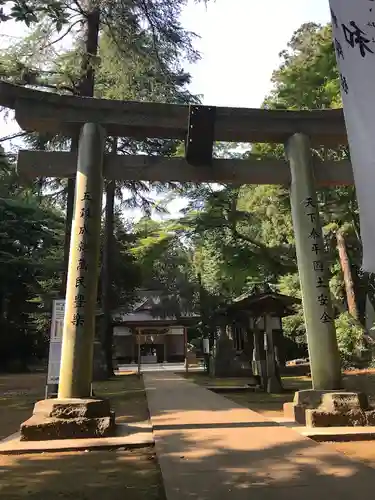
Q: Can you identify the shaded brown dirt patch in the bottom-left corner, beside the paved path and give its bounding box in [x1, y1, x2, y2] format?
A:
[0, 449, 165, 500]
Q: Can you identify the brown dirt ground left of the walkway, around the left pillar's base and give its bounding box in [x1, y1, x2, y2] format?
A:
[0, 374, 165, 500]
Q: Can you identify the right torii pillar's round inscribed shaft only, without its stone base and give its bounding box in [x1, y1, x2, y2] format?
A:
[286, 134, 342, 390]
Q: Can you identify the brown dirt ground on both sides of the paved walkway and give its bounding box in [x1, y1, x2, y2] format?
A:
[0, 372, 375, 494]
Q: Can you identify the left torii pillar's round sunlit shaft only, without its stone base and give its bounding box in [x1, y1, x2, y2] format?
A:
[59, 123, 105, 399]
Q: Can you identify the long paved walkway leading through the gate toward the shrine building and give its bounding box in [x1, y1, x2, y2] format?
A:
[144, 373, 375, 500]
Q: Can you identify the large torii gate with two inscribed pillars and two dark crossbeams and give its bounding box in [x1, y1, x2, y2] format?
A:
[0, 82, 362, 440]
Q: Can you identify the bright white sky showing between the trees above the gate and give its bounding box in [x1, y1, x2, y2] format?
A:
[0, 0, 330, 219]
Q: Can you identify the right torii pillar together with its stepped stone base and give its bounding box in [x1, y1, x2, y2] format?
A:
[284, 133, 373, 427]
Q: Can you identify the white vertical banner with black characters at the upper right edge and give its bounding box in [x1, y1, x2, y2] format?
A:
[330, 0, 375, 272]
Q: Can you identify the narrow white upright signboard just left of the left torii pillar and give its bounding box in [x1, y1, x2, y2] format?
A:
[46, 299, 65, 396]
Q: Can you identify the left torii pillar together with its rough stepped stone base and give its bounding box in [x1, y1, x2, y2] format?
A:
[21, 123, 115, 441]
